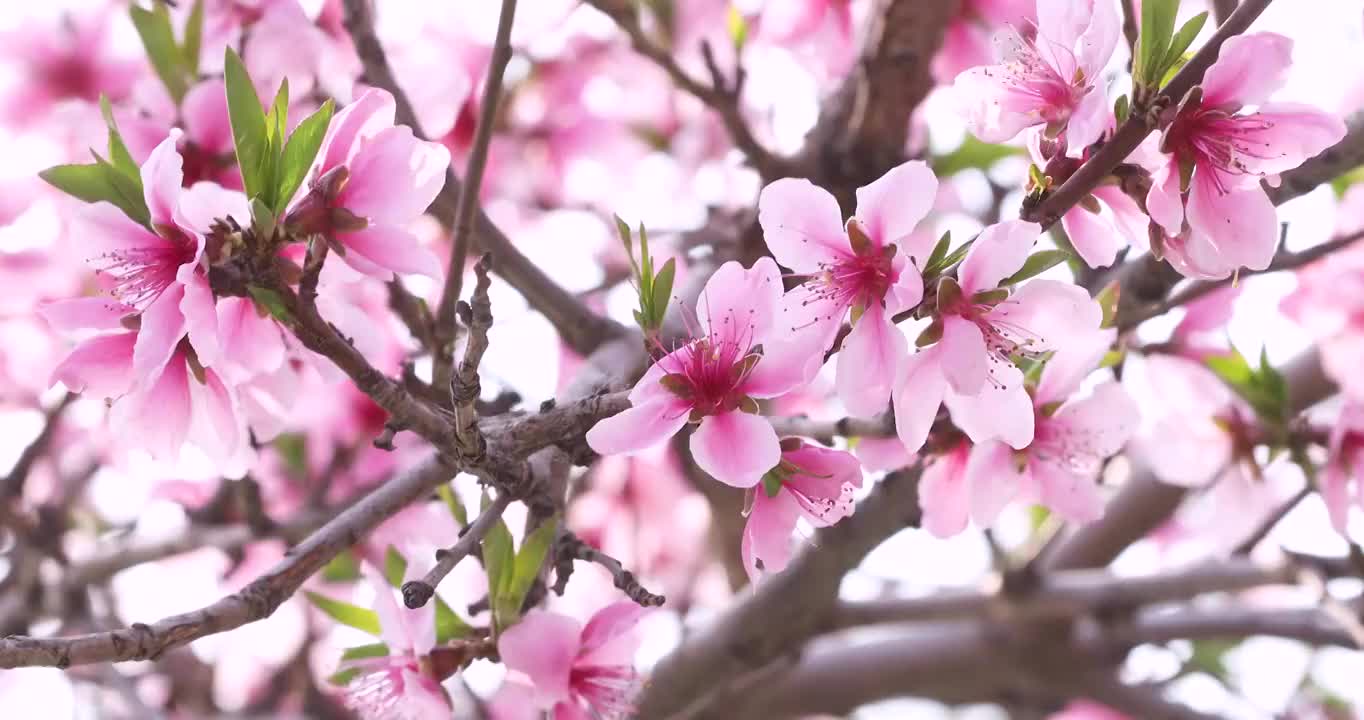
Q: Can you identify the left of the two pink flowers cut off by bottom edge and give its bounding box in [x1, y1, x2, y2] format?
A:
[342, 565, 451, 720]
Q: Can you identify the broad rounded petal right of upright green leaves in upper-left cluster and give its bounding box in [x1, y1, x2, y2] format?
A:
[337, 127, 450, 225]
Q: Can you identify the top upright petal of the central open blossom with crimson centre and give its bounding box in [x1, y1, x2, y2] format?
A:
[696, 258, 783, 345]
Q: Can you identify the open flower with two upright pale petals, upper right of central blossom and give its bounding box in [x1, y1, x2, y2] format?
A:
[758, 161, 938, 416]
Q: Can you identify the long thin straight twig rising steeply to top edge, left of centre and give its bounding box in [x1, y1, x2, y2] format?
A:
[431, 0, 516, 387]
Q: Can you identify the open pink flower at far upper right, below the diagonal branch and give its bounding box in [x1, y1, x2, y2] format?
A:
[1146, 33, 1345, 278]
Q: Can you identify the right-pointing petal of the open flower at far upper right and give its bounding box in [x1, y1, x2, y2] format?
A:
[1240, 102, 1345, 175]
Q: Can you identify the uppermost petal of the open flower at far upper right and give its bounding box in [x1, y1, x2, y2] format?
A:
[1203, 33, 1293, 109]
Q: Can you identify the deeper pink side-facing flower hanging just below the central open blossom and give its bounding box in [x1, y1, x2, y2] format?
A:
[742, 438, 862, 581]
